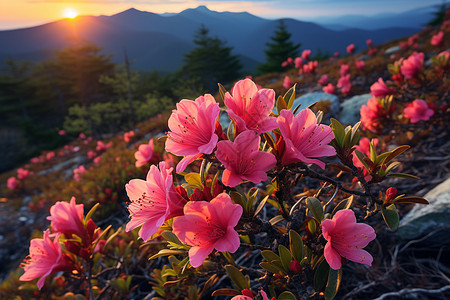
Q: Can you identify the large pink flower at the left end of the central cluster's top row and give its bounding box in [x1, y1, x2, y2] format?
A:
[166, 94, 220, 172]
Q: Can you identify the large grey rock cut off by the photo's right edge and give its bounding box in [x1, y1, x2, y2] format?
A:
[397, 177, 450, 240]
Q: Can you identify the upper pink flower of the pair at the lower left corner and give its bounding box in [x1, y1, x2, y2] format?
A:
[47, 197, 85, 238]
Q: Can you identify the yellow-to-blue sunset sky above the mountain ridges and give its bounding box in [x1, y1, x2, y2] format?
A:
[0, 0, 443, 30]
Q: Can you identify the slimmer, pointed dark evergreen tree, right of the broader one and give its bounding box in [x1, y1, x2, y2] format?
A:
[257, 20, 301, 74]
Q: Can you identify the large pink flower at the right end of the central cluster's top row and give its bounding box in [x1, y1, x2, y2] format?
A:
[277, 109, 336, 169]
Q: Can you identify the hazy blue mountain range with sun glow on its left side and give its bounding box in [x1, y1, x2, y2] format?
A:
[0, 6, 427, 72]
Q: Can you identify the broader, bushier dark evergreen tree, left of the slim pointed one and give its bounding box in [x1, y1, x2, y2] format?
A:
[179, 25, 242, 93]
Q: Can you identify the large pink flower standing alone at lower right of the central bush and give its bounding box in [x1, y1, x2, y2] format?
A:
[322, 209, 376, 270]
